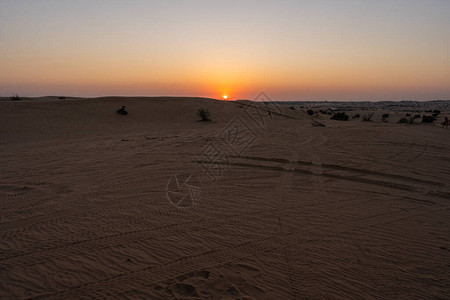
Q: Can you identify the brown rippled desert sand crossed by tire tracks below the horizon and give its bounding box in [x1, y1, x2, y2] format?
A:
[0, 97, 450, 299]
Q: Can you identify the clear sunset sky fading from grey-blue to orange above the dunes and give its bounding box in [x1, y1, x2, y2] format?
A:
[0, 0, 450, 100]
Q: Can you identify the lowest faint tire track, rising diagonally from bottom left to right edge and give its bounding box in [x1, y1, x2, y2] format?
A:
[29, 206, 449, 299]
